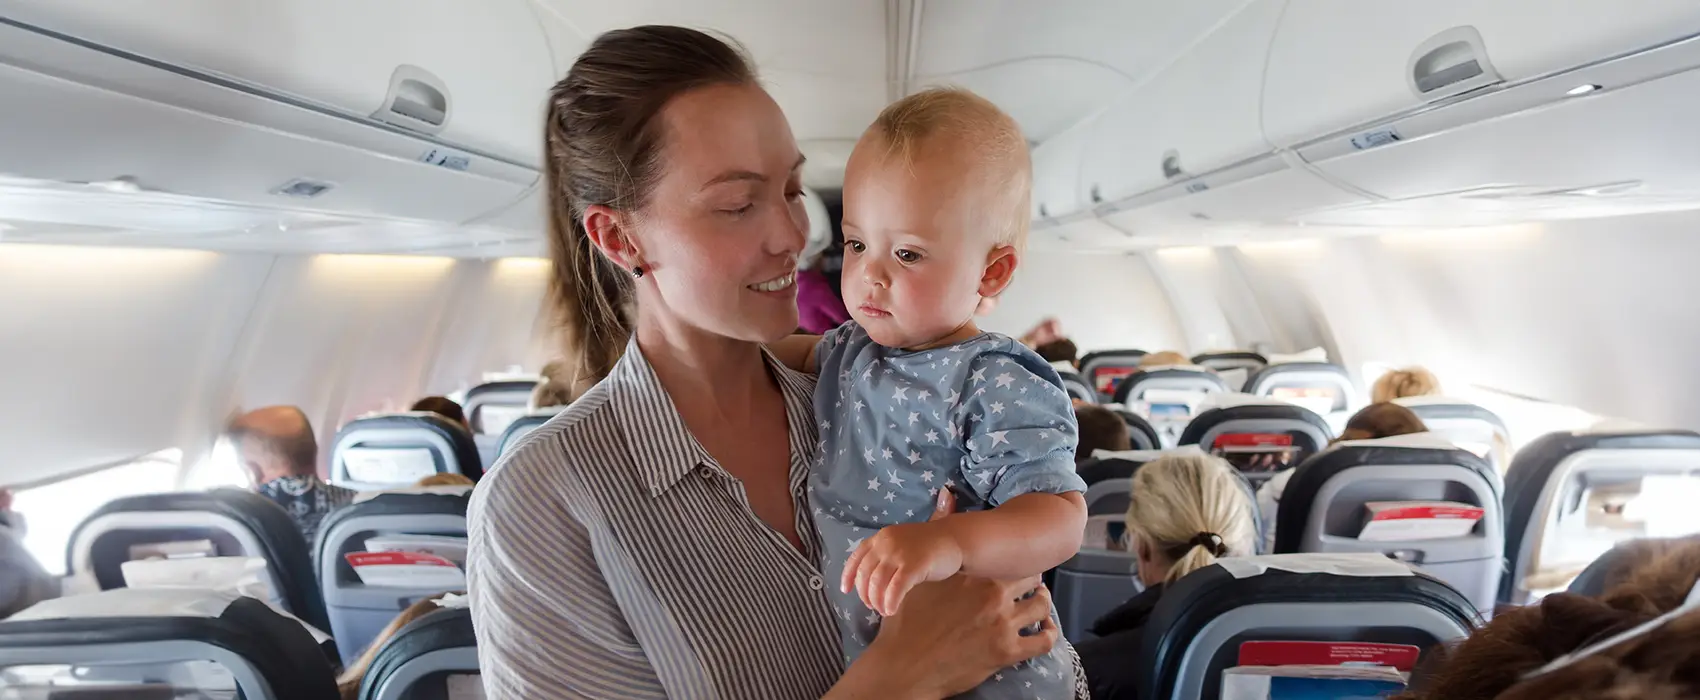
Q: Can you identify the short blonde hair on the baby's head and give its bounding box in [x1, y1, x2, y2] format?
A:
[869, 87, 1034, 251]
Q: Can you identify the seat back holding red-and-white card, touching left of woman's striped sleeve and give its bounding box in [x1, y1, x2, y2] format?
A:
[315, 488, 473, 664]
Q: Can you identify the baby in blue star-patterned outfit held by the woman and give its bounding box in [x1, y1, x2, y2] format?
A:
[774, 90, 1086, 698]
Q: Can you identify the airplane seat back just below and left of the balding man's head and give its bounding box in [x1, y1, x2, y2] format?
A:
[65, 488, 330, 630]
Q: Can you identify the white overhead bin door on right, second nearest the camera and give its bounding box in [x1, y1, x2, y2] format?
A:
[1080, 0, 1285, 206]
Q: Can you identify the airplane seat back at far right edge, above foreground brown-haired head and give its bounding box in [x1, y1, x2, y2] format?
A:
[1499, 430, 1700, 605]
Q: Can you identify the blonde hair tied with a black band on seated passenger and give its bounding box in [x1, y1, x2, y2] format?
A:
[1127, 454, 1256, 583]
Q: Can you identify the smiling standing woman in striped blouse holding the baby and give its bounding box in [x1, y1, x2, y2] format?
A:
[468, 27, 1056, 700]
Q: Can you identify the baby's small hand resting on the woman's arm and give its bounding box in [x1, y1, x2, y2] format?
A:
[840, 522, 962, 615]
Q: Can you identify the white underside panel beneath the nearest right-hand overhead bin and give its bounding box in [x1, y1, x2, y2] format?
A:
[1299, 25, 1700, 226]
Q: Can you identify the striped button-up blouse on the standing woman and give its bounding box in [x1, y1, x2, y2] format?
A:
[468, 342, 843, 700]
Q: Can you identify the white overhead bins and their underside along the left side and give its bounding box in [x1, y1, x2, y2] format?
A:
[0, 0, 554, 224]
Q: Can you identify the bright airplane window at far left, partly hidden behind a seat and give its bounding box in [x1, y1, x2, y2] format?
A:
[12, 449, 184, 576]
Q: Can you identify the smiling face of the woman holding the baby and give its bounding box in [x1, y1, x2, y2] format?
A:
[631, 85, 809, 342]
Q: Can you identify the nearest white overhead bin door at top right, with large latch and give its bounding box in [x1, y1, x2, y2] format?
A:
[1263, 0, 1700, 146]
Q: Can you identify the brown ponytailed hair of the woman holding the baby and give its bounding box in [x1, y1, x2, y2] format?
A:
[544, 25, 757, 394]
